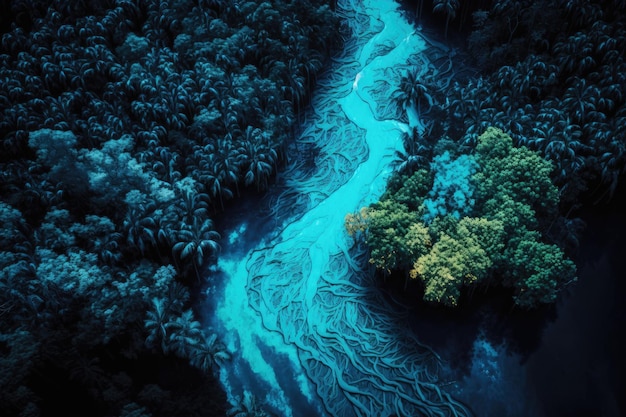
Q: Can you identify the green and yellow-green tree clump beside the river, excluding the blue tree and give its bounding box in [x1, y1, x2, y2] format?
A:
[346, 128, 576, 308]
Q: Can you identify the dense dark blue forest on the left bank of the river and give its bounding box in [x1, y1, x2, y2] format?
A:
[0, 0, 341, 416]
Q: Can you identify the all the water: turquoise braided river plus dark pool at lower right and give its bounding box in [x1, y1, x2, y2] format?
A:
[204, 0, 626, 417]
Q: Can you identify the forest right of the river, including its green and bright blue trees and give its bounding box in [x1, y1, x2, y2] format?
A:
[346, 0, 626, 309]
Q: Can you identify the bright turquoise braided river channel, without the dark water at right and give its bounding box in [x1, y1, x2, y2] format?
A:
[210, 0, 471, 417]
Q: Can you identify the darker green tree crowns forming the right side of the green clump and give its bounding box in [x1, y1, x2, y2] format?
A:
[474, 128, 576, 308]
